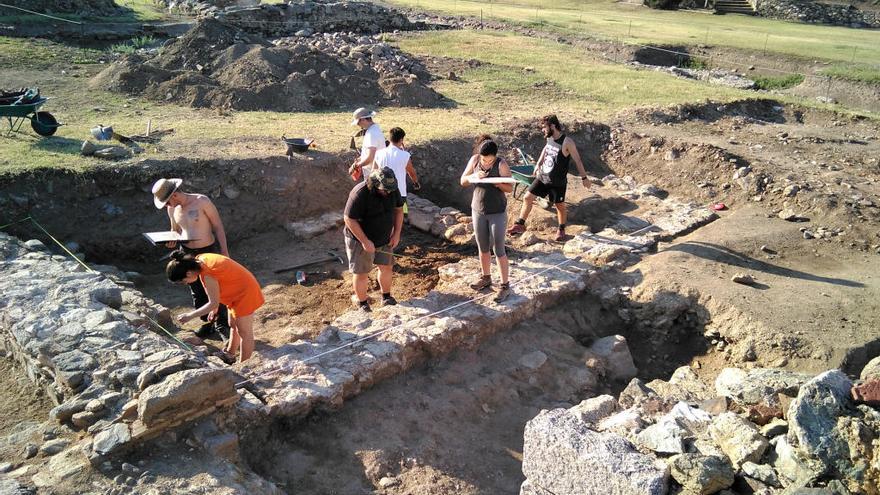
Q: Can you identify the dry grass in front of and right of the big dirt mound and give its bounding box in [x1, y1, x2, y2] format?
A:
[0, 31, 868, 172]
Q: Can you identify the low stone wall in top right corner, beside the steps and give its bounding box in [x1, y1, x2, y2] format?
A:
[756, 0, 880, 28]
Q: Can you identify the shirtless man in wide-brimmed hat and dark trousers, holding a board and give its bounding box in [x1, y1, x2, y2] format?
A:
[153, 179, 229, 338]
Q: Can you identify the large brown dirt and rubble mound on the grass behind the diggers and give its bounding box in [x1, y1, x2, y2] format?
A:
[93, 19, 448, 112]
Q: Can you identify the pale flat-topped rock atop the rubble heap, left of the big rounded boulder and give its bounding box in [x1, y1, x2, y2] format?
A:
[715, 368, 812, 405]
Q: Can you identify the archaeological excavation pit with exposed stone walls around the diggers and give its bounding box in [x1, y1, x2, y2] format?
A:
[0, 103, 871, 494]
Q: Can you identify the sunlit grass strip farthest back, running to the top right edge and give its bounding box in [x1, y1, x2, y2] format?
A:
[388, 0, 880, 64]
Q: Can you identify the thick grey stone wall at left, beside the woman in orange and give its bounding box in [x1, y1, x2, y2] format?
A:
[0, 234, 239, 472]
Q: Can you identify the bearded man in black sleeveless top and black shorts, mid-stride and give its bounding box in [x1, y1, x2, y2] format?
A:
[507, 115, 590, 242]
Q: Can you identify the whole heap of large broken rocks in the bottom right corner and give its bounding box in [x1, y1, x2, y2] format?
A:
[520, 358, 880, 495]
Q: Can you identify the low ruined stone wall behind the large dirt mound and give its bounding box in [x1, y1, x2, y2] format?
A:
[161, 0, 416, 37]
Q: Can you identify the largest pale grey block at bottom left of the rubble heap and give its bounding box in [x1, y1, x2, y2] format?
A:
[522, 409, 669, 495]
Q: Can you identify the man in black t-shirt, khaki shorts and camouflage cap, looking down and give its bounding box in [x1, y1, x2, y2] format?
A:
[345, 167, 403, 312]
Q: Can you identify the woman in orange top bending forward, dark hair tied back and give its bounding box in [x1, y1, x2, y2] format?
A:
[165, 251, 265, 363]
